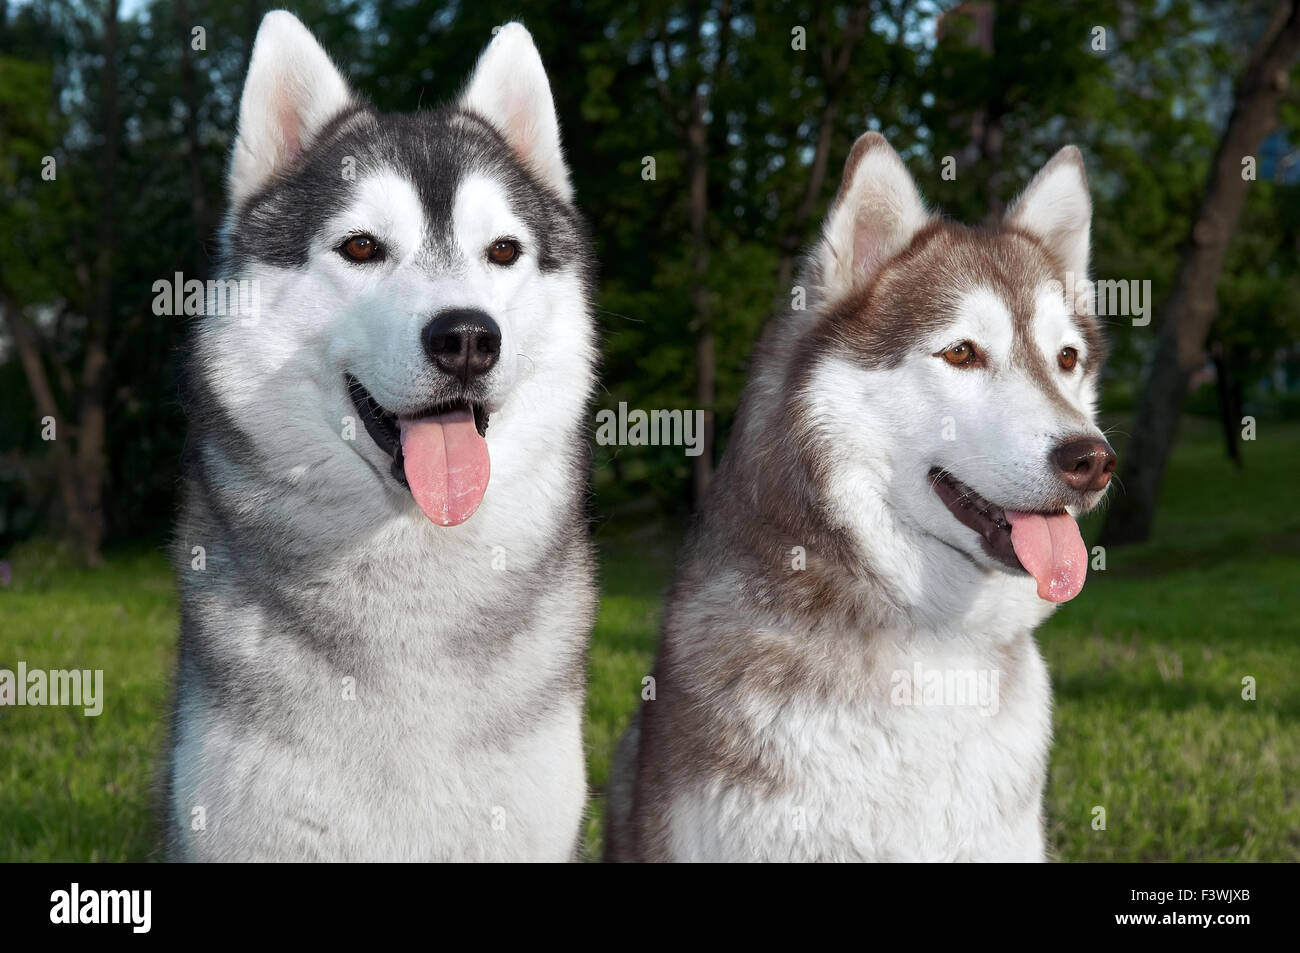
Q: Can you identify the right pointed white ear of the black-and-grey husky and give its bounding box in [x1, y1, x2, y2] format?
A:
[460, 23, 573, 202]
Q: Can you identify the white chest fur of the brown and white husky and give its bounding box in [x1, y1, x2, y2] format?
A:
[668, 624, 1050, 861]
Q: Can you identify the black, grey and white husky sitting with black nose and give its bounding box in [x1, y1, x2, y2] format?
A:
[166, 12, 595, 861]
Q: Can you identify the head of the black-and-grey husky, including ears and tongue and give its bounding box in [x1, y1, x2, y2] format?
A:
[215, 13, 590, 525]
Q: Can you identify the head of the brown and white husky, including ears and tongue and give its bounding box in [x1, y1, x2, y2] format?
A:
[803, 135, 1115, 602]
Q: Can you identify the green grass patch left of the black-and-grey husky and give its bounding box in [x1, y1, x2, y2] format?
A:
[0, 546, 177, 861]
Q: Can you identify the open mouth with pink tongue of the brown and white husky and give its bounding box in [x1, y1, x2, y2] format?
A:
[930, 467, 1088, 602]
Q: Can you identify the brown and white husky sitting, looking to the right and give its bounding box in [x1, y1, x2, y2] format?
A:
[607, 133, 1115, 861]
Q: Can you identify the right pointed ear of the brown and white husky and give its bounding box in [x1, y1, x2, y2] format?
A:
[1004, 146, 1092, 280]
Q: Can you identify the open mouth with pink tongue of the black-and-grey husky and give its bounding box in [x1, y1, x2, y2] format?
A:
[346, 374, 491, 527]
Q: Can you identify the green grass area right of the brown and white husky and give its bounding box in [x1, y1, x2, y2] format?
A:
[1039, 419, 1300, 861]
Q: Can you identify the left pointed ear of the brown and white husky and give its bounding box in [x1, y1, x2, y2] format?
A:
[815, 133, 930, 298]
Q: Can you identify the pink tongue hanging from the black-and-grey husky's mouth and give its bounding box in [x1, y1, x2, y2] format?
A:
[398, 407, 491, 527]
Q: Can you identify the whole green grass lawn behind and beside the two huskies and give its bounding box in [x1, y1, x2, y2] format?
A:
[0, 419, 1300, 861]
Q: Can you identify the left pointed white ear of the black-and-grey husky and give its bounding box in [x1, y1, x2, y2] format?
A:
[228, 10, 352, 205]
